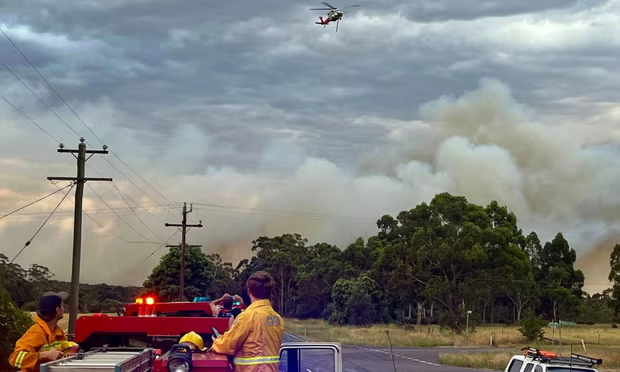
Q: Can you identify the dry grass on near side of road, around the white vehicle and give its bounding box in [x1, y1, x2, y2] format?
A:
[439, 346, 620, 371]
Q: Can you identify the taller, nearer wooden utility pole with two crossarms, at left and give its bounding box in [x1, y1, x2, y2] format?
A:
[47, 137, 112, 340]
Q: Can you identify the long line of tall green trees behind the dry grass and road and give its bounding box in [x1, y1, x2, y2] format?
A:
[144, 193, 620, 332]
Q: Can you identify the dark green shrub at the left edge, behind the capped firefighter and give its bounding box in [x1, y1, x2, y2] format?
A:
[0, 287, 34, 370]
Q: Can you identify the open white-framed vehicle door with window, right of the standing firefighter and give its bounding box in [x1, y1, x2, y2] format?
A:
[280, 342, 342, 372]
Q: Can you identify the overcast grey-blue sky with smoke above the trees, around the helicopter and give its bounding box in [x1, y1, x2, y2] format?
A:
[0, 0, 620, 289]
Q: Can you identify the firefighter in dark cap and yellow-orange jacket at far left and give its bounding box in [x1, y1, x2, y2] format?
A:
[9, 292, 78, 372]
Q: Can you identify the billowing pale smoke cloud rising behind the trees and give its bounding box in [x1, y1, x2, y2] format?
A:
[0, 79, 620, 290]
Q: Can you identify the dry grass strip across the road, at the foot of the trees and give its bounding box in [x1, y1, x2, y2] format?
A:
[285, 319, 620, 347]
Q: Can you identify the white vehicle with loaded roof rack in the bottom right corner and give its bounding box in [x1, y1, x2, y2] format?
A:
[504, 347, 603, 372]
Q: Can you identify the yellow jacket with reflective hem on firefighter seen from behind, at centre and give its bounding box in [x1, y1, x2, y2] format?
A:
[211, 300, 284, 372]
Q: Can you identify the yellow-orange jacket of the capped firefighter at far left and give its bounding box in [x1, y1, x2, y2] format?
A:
[9, 315, 77, 372]
